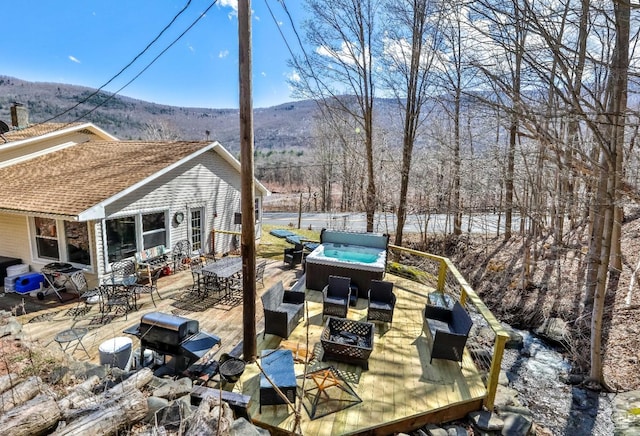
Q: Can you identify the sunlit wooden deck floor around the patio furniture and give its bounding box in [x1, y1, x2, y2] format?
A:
[0, 260, 486, 435]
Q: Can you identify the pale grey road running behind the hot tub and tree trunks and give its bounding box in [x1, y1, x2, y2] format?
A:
[263, 212, 519, 235]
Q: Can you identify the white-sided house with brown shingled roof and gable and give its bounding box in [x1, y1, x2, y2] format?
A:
[0, 110, 270, 279]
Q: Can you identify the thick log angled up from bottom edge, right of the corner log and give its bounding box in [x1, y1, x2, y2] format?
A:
[53, 389, 148, 436]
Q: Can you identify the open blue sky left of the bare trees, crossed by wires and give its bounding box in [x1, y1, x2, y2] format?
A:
[0, 0, 304, 108]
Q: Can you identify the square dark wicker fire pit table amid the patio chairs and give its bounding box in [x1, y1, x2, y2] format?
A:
[320, 316, 374, 369]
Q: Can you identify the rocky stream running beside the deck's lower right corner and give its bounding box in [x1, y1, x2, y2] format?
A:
[502, 330, 614, 436]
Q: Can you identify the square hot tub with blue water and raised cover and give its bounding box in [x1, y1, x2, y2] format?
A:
[305, 230, 388, 298]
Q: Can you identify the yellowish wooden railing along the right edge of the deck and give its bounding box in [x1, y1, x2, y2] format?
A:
[387, 245, 509, 410]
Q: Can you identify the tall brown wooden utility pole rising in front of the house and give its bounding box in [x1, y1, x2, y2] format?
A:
[238, 0, 258, 362]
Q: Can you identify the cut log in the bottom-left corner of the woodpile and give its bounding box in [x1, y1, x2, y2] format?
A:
[0, 394, 62, 436]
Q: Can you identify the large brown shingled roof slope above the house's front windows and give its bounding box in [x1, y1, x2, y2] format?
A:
[0, 141, 214, 217]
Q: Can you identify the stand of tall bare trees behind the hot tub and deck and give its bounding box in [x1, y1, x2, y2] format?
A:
[276, 0, 640, 383]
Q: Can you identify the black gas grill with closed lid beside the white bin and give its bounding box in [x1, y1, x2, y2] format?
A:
[124, 312, 220, 374]
